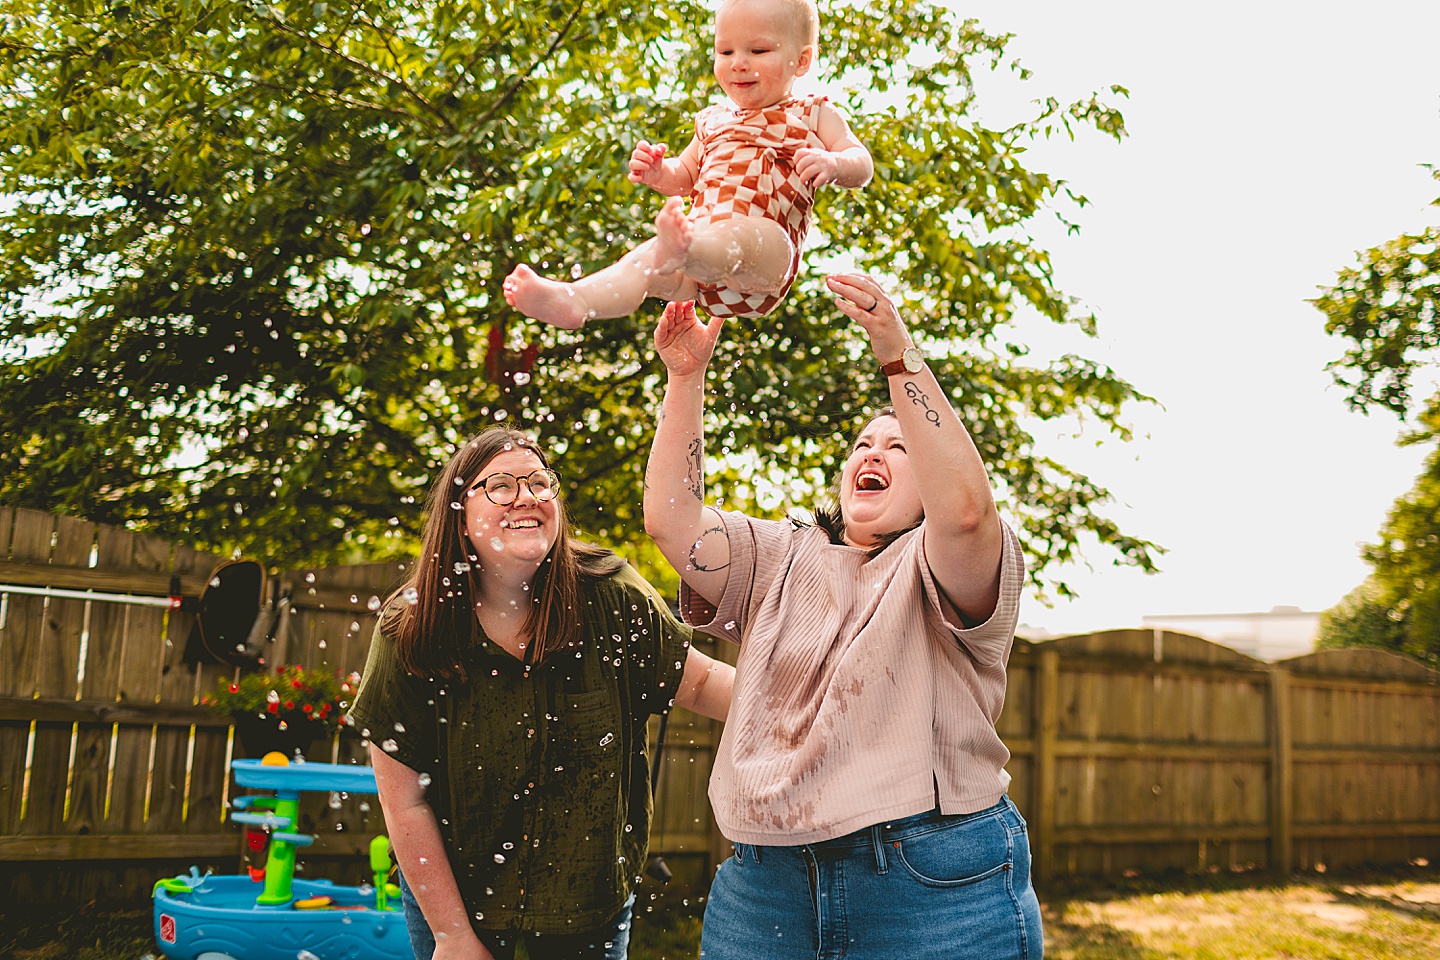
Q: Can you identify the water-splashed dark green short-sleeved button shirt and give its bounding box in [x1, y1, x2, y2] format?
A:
[350, 566, 690, 934]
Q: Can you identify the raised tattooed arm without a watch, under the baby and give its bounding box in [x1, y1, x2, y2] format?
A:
[645, 302, 730, 603]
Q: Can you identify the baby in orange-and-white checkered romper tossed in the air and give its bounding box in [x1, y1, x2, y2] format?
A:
[504, 0, 874, 330]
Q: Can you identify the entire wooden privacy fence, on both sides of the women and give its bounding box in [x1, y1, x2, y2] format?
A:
[0, 508, 1440, 902]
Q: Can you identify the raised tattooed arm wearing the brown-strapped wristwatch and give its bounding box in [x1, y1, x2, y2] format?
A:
[825, 273, 1002, 623]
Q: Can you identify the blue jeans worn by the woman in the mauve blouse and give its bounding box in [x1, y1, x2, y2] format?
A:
[700, 797, 1044, 960]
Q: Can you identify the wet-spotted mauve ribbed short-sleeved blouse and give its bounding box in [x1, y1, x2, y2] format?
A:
[680, 512, 1024, 845]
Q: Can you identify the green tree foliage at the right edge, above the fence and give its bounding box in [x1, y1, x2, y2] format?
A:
[1313, 171, 1440, 659]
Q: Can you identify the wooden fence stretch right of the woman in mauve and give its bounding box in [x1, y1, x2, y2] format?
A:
[999, 630, 1440, 884]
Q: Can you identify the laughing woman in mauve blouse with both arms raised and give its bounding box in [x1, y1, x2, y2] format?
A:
[645, 273, 1044, 960]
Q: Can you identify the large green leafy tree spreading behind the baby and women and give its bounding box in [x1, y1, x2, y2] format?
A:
[0, 0, 1153, 596]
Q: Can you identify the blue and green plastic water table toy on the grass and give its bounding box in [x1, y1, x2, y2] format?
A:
[153, 753, 415, 960]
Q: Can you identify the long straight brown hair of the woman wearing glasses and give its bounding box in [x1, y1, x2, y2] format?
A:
[382, 426, 625, 679]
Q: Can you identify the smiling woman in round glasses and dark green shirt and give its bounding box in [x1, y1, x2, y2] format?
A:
[348, 427, 734, 960]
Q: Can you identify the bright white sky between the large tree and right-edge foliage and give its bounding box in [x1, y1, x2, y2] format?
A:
[955, 0, 1440, 633]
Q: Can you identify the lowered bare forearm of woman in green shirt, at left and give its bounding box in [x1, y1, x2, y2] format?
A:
[370, 744, 494, 960]
